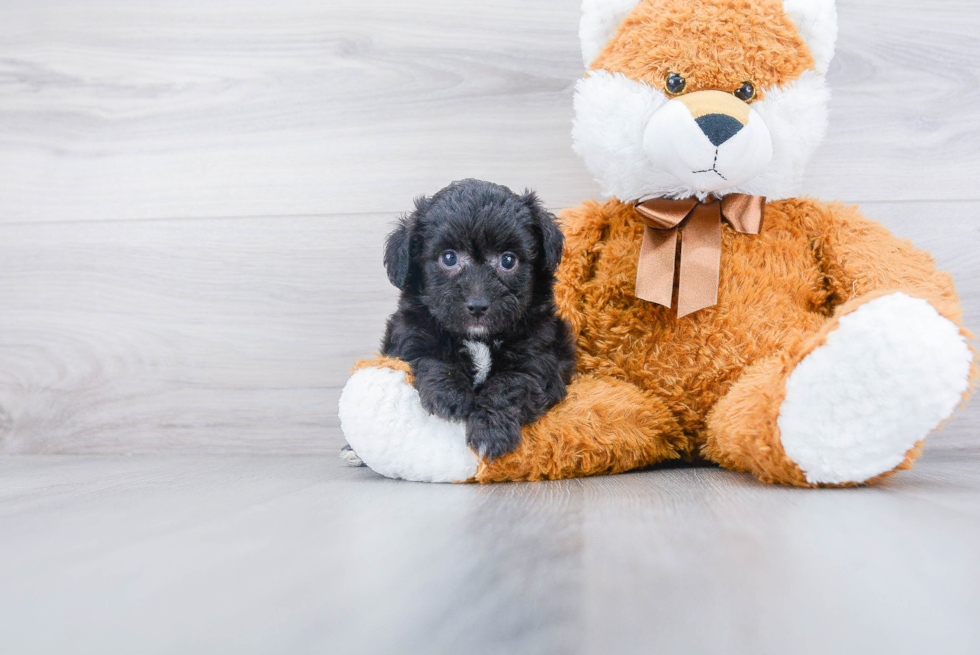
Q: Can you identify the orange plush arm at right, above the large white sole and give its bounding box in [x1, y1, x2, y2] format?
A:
[799, 201, 962, 325]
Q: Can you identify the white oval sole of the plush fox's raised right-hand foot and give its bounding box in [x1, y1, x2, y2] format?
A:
[778, 293, 973, 484]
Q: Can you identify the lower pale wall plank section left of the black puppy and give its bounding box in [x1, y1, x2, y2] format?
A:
[0, 215, 396, 453]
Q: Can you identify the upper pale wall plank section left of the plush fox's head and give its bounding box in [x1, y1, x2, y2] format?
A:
[0, 0, 592, 221]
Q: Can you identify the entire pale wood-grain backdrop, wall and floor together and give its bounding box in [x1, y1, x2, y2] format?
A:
[0, 0, 980, 655]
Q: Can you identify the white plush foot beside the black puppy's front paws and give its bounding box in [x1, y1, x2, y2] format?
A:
[340, 368, 480, 482]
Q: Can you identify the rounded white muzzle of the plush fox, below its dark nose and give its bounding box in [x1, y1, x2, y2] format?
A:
[643, 99, 772, 194]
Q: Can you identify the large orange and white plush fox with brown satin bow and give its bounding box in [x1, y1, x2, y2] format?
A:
[340, 0, 976, 487]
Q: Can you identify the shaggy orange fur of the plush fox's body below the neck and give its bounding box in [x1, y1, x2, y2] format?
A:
[477, 199, 966, 486]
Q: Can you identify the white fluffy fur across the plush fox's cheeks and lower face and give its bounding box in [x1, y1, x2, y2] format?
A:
[572, 70, 830, 202]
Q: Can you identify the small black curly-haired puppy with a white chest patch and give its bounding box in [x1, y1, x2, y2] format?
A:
[381, 180, 575, 459]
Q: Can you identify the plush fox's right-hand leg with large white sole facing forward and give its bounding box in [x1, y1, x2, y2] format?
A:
[702, 293, 974, 487]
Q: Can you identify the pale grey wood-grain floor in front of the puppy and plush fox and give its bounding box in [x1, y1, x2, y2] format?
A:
[0, 456, 980, 655]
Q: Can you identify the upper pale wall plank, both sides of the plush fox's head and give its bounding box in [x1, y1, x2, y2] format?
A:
[0, 0, 980, 222]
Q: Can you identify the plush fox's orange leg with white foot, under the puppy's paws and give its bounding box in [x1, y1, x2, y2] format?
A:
[340, 358, 687, 482]
